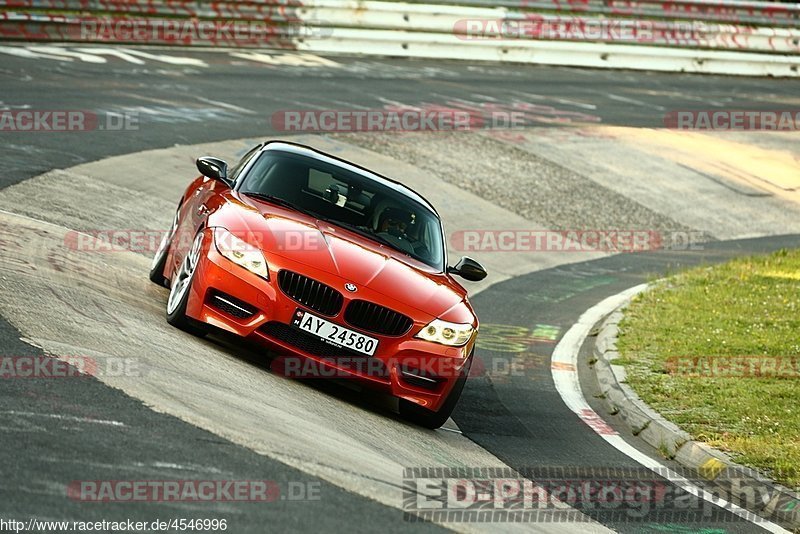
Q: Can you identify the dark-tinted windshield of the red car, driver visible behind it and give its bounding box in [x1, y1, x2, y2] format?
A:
[239, 151, 444, 270]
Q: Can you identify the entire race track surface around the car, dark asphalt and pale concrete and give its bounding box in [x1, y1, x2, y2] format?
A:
[0, 46, 800, 533]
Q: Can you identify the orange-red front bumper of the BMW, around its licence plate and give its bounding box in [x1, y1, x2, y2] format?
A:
[186, 230, 475, 411]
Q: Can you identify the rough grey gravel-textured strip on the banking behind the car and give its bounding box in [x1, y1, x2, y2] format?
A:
[333, 132, 704, 239]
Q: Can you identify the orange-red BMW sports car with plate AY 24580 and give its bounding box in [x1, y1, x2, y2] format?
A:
[150, 141, 486, 428]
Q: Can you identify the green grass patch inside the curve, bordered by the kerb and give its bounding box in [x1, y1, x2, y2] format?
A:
[618, 250, 800, 488]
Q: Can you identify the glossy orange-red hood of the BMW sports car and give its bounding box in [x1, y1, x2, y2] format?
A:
[216, 198, 471, 320]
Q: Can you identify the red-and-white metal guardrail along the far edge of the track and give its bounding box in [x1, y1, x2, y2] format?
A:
[0, 0, 800, 76]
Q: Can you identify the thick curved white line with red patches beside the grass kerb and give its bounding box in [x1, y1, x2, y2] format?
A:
[550, 284, 791, 534]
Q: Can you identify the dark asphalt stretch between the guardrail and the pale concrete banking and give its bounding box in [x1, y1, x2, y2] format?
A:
[0, 46, 797, 184]
